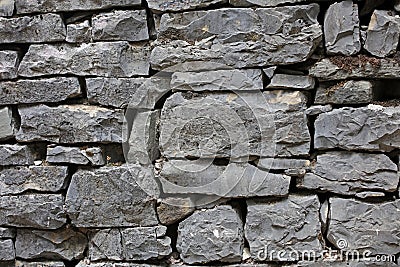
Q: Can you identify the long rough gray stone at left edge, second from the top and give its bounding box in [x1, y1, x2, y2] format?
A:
[0, 14, 66, 43]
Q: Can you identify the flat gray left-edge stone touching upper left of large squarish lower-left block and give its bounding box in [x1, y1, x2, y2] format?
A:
[0, 166, 68, 195]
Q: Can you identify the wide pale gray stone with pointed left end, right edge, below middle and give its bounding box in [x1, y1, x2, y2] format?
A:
[297, 152, 399, 195]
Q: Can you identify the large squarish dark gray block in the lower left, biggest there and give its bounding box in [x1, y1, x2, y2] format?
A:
[66, 166, 158, 227]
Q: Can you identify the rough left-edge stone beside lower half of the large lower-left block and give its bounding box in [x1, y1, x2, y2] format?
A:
[0, 194, 67, 229]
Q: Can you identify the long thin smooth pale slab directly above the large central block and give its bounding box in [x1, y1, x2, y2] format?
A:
[171, 69, 263, 91]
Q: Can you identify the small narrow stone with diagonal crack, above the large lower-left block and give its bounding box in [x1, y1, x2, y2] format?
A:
[46, 146, 105, 166]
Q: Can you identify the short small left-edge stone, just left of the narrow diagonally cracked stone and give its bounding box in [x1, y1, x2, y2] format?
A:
[0, 145, 34, 166]
